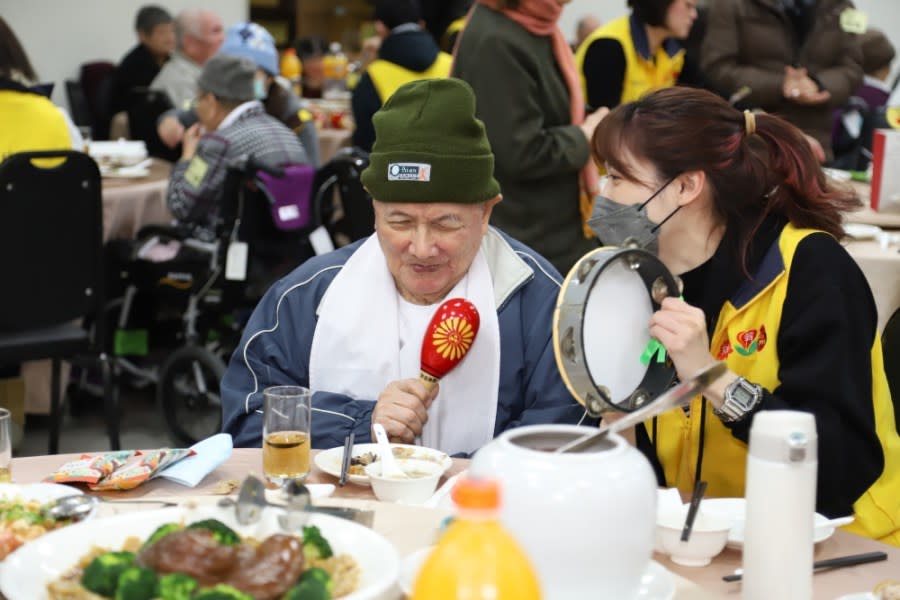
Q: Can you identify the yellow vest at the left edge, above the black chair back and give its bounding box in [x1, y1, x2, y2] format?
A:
[0, 90, 72, 161]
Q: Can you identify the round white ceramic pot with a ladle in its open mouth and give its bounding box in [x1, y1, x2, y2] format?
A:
[470, 425, 656, 600]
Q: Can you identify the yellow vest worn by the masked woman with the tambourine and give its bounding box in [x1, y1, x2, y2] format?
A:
[645, 225, 900, 546]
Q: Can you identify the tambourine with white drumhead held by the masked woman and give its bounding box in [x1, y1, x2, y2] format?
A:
[553, 247, 681, 417]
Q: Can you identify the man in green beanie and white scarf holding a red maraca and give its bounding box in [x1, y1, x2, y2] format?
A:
[221, 79, 584, 454]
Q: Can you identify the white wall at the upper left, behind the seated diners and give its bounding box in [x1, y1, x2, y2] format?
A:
[0, 0, 249, 106]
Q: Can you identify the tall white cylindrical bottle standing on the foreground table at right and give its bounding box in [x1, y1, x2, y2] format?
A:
[742, 410, 818, 600]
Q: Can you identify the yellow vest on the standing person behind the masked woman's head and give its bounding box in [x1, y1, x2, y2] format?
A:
[575, 16, 684, 104]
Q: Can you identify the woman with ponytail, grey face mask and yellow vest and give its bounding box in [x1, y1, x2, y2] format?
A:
[590, 87, 900, 546]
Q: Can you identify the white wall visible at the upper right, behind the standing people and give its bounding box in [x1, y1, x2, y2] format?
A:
[559, 0, 900, 79]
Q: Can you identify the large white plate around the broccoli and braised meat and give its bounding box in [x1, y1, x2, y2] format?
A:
[0, 506, 400, 600]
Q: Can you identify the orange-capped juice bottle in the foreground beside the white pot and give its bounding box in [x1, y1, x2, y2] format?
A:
[412, 479, 541, 600]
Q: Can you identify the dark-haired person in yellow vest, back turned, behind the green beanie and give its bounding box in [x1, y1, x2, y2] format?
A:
[352, 0, 452, 152]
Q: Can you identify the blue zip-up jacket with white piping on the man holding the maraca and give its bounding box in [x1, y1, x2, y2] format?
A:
[221, 228, 595, 448]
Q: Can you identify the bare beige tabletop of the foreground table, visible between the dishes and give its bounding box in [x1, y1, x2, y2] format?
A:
[13, 449, 900, 600]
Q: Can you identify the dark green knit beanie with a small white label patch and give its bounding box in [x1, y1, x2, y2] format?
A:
[362, 78, 500, 204]
